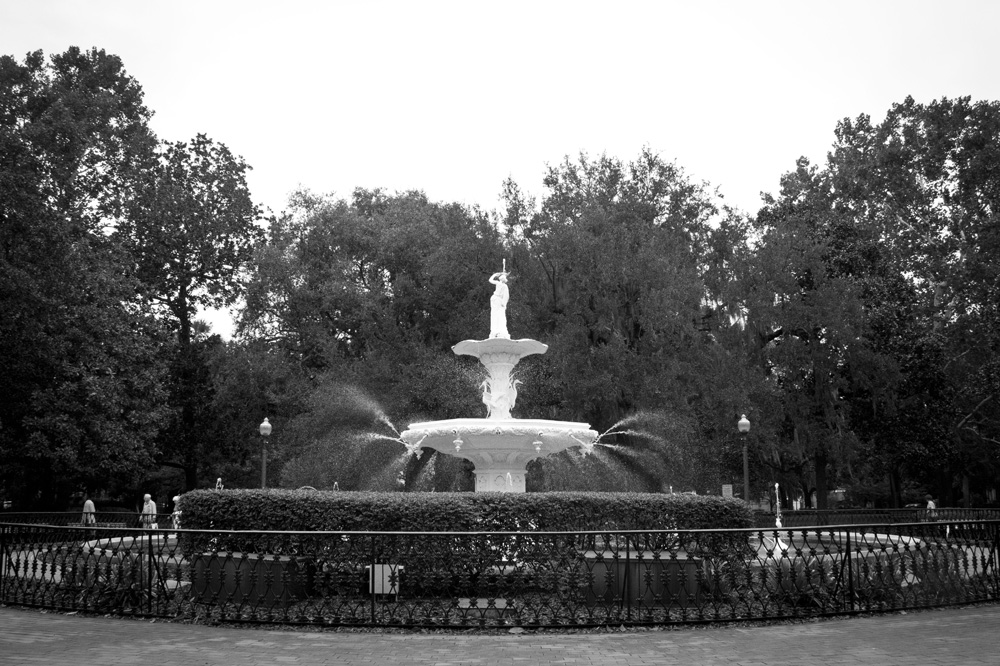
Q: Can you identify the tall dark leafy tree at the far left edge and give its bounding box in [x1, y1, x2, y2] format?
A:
[0, 47, 163, 506]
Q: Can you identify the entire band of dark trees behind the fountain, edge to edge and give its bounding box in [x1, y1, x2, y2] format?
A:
[0, 48, 1000, 508]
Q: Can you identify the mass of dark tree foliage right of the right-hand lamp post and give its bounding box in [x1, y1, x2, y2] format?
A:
[739, 98, 1000, 505]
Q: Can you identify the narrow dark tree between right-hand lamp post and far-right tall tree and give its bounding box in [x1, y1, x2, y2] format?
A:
[734, 159, 885, 508]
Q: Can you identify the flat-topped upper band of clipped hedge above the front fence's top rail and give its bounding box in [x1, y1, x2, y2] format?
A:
[181, 490, 754, 532]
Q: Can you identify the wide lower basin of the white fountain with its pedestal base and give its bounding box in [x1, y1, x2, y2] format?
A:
[401, 418, 597, 492]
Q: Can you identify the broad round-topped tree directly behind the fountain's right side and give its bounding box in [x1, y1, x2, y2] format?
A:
[502, 150, 743, 490]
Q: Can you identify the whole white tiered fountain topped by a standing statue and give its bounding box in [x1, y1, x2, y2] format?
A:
[401, 272, 598, 493]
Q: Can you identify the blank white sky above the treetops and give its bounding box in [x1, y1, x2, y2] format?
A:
[0, 0, 1000, 328]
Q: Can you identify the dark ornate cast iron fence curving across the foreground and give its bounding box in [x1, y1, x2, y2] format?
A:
[0, 517, 1000, 628]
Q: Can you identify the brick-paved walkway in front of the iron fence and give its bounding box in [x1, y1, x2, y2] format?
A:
[0, 605, 1000, 666]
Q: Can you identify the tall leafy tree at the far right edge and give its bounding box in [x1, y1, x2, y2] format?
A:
[827, 97, 1000, 503]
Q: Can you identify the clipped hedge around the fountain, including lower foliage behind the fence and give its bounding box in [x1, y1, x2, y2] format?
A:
[181, 490, 752, 597]
